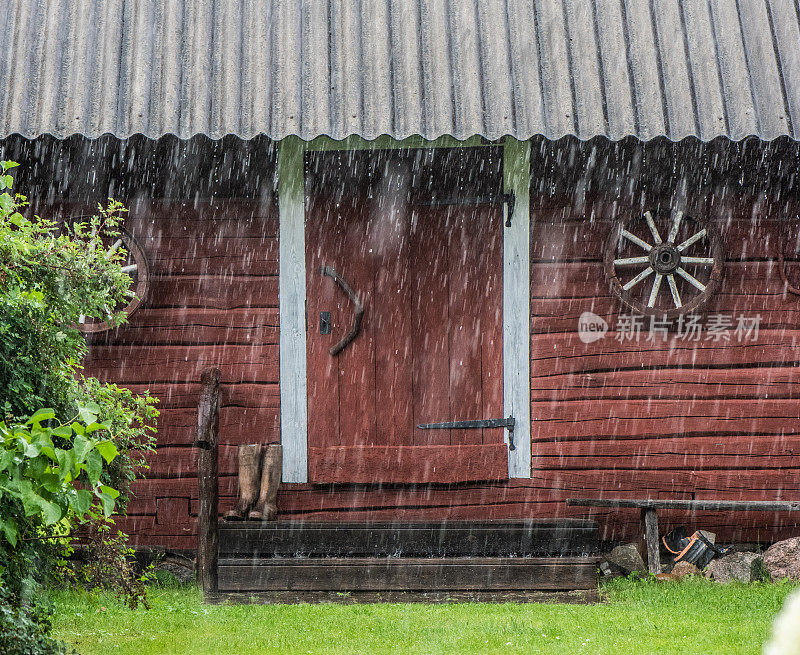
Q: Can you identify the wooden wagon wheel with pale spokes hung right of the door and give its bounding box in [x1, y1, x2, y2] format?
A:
[605, 210, 723, 318]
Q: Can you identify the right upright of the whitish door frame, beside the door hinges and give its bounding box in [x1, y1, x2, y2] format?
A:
[503, 137, 531, 478]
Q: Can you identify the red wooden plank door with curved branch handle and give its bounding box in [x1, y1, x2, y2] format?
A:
[306, 151, 508, 483]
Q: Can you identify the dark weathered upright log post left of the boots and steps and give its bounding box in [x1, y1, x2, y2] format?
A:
[194, 368, 222, 593]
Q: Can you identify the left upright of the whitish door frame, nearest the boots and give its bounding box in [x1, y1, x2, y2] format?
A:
[278, 136, 308, 482]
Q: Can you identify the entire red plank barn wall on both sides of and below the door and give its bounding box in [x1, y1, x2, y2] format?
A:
[50, 136, 800, 548]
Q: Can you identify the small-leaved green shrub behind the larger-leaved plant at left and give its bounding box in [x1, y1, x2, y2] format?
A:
[0, 162, 158, 511]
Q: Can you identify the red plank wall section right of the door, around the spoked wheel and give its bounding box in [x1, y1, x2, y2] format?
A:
[531, 194, 800, 541]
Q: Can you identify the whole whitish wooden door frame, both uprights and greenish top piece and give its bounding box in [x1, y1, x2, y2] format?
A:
[277, 136, 531, 482]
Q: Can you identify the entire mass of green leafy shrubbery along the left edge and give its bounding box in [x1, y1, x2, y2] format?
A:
[0, 162, 158, 652]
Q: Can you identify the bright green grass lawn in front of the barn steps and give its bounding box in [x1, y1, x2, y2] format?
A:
[52, 580, 794, 655]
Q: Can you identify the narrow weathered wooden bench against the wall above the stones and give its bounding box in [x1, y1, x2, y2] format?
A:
[567, 498, 800, 573]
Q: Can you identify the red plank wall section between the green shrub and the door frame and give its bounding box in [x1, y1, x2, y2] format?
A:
[75, 198, 280, 548]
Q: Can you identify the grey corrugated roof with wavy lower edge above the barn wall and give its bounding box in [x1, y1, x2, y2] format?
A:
[0, 0, 800, 140]
